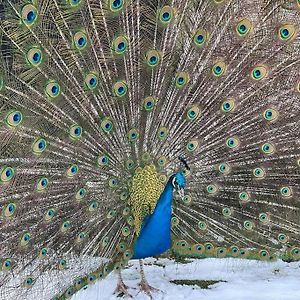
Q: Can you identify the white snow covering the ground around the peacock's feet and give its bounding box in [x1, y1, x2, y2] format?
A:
[72, 258, 300, 300]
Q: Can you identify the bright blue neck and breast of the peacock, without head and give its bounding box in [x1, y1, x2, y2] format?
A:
[132, 181, 173, 259]
